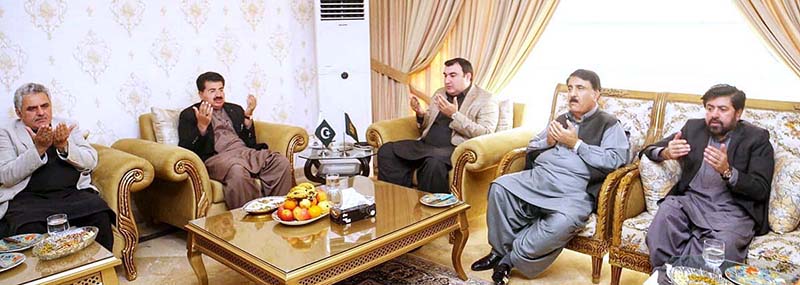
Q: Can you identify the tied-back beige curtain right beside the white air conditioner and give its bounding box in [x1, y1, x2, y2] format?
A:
[370, 0, 463, 121]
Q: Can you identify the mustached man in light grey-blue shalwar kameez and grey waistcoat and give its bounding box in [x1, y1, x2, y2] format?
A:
[472, 69, 629, 284]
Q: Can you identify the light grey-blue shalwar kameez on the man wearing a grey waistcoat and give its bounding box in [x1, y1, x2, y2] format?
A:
[486, 107, 628, 278]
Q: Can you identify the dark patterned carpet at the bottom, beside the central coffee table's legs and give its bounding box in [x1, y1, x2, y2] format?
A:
[338, 254, 492, 285]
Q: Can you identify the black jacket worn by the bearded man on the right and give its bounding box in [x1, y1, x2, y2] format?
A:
[639, 119, 775, 235]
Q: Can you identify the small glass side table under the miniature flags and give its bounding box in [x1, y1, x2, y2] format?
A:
[298, 145, 377, 183]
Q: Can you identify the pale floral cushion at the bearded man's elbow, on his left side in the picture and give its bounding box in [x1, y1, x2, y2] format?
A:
[639, 155, 681, 215]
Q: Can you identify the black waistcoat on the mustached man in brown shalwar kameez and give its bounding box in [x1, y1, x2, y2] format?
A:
[178, 103, 267, 161]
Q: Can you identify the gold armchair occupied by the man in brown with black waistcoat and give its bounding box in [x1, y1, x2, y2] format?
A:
[107, 111, 308, 228]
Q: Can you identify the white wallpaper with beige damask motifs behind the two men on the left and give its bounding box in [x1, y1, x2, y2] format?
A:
[0, 0, 318, 145]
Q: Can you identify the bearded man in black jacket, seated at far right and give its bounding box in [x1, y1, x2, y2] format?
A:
[639, 84, 775, 278]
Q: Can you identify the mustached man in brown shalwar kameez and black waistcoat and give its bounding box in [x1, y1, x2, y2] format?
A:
[178, 72, 292, 209]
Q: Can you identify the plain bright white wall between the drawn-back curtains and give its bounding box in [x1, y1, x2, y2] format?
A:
[501, 0, 800, 130]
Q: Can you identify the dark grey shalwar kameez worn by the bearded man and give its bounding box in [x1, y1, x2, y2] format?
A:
[646, 136, 755, 267]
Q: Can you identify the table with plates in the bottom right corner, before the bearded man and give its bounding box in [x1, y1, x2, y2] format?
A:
[666, 255, 796, 285]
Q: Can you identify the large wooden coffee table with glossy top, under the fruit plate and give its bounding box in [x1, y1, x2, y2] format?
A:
[186, 176, 469, 285]
